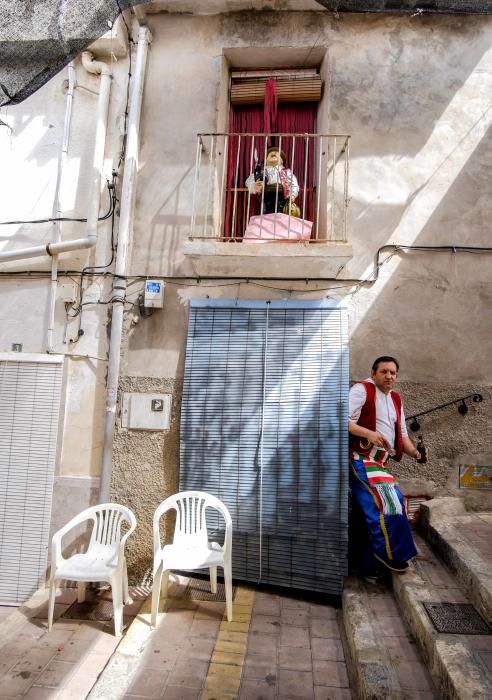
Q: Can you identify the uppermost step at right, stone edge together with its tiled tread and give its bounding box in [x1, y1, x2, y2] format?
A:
[420, 498, 492, 625]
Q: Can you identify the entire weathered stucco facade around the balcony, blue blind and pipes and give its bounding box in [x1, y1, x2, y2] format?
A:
[0, 5, 492, 584]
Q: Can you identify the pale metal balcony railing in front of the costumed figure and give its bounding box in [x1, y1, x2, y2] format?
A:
[190, 133, 350, 243]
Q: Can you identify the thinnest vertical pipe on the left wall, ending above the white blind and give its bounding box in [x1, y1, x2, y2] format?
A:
[46, 61, 75, 353]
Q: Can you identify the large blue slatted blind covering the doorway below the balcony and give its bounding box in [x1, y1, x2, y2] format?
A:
[180, 300, 348, 595]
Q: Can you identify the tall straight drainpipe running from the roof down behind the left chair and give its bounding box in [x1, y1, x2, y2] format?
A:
[99, 27, 152, 503]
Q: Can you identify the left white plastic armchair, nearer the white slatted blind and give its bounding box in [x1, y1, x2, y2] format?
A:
[48, 503, 137, 637]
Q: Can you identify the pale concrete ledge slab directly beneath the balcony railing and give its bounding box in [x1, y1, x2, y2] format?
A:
[183, 240, 352, 279]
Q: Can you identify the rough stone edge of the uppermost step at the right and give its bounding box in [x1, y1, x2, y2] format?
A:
[422, 509, 492, 624]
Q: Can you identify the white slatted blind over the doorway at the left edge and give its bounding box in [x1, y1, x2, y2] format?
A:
[0, 355, 63, 605]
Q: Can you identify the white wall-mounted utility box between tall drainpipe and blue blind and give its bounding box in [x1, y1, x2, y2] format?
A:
[121, 393, 172, 430]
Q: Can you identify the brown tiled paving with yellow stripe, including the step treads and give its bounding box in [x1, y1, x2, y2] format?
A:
[0, 523, 492, 700]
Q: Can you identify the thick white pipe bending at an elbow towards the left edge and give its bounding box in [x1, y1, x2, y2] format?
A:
[0, 51, 112, 262]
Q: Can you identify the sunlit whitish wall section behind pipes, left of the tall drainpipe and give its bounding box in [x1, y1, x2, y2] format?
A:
[0, 44, 128, 546]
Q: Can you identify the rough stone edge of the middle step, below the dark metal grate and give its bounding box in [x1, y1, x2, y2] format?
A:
[393, 567, 492, 700]
